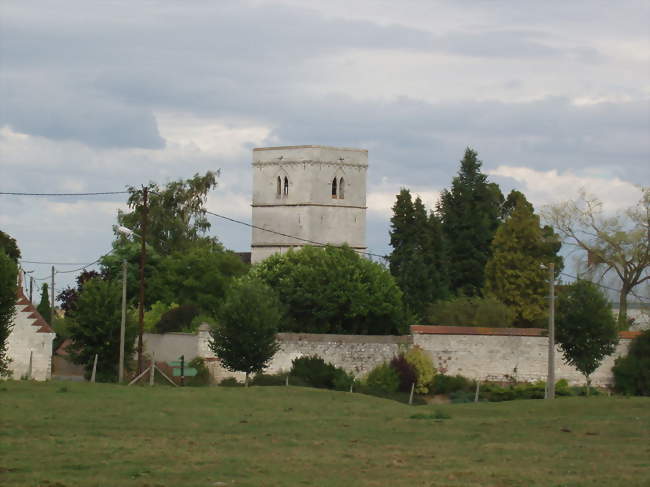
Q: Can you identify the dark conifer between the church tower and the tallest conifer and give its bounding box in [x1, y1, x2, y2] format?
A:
[389, 189, 448, 319]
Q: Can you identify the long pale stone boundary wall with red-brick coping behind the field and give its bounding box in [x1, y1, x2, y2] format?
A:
[139, 325, 637, 386]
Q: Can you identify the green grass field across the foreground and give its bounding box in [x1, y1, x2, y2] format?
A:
[0, 382, 650, 487]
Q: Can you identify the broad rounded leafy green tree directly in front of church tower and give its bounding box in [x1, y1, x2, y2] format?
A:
[254, 247, 407, 335]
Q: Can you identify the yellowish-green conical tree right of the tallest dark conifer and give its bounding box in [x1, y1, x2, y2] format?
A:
[485, 191, 561, 327]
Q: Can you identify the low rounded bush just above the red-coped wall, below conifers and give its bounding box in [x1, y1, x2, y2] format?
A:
[426, 297, 515, 328]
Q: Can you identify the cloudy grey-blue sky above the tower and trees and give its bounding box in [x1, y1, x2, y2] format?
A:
[0, 0, 650, 296]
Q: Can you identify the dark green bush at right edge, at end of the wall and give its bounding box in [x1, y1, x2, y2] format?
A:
[612, 330, 650, 396]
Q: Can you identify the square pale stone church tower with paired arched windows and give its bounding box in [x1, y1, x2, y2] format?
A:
[251, 145, 368, 263]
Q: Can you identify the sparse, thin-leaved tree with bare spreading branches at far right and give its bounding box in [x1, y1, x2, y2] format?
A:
[545, 187, 650, 329]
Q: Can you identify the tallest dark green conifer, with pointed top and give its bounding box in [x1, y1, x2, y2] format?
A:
[438, 148, 503, 296]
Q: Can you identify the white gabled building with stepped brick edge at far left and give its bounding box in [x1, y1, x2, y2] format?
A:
[7, 285, 56, 380]
